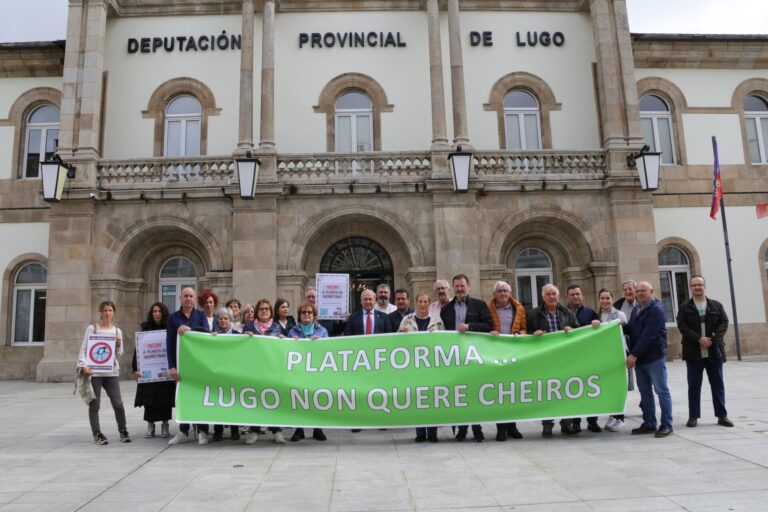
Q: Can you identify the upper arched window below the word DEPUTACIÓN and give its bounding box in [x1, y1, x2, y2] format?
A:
[163, 95, 203, 156]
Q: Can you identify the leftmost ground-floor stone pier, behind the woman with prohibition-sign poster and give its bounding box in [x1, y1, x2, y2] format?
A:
[37, 201, 98, 382]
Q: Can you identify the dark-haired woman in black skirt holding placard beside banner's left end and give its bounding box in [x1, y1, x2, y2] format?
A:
[131, 302, 176, 438]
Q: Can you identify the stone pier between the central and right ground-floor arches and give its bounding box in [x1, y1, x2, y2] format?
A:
[432, 191, 482, 288]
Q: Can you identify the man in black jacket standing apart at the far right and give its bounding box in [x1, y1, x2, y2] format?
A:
[677, 275, 733, 427]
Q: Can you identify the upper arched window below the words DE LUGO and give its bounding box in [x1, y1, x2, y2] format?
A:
[504, 89, 541, 151]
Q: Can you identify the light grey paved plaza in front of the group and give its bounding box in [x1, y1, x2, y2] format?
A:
[0, 361, 768, 512]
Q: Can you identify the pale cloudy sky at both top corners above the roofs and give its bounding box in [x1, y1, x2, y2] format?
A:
[0, 0, 768, 42]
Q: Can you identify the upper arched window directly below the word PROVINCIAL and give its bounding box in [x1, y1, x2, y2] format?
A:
[334, 91, 373, 153]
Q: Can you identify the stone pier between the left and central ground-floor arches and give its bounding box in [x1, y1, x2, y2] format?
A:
[232, 194, 278, 300]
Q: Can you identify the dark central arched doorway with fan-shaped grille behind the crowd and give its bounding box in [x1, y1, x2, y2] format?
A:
[320, 236, 395, 311]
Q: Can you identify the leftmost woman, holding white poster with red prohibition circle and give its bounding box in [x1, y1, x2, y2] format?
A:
[77, 301, 131, 445]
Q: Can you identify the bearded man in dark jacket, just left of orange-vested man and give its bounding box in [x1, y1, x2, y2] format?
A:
[440, 274, 493, 443]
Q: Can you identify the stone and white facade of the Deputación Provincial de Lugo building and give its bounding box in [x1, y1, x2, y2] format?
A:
[0, 0, 768, 381]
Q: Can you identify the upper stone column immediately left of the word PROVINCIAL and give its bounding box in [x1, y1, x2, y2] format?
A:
[259, 0, 275, 152]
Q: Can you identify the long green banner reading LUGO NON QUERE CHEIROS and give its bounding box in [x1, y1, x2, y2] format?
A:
[176, 322, 627, 428]
